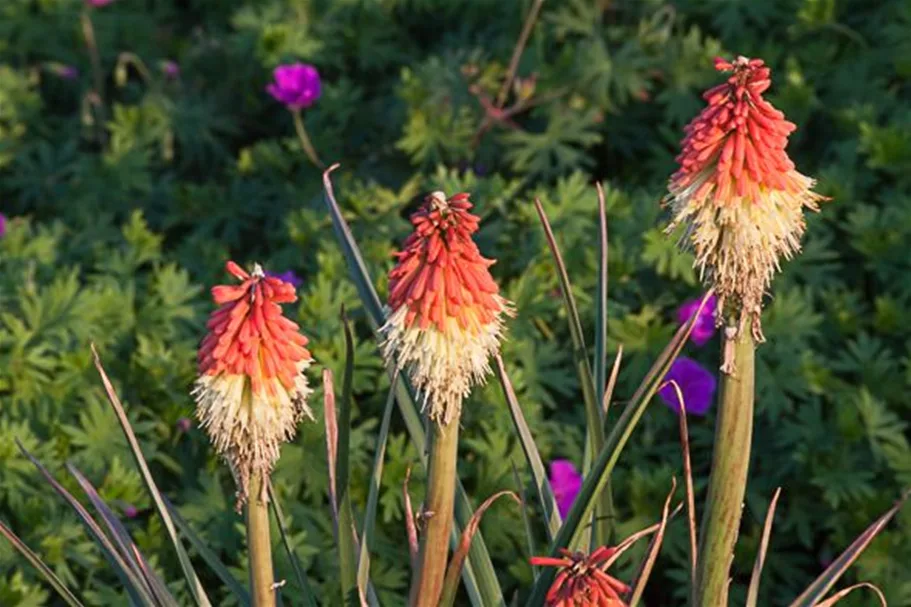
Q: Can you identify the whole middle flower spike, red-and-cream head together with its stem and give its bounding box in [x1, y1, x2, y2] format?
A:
[380, 192, 511, 606]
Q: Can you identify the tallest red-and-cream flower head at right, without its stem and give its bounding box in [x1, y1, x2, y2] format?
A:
[666, 57, 825, 341]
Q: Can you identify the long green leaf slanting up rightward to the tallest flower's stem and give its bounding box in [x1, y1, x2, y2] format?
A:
[527, 294, 708, 607]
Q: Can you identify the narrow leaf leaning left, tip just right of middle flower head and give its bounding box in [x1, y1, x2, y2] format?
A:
[535, 198, 614, 545]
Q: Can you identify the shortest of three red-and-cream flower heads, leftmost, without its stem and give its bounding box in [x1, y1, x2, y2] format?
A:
[193, 261, 312, 507]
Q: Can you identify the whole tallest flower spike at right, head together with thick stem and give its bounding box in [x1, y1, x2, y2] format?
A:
[666, 57, 824, 605]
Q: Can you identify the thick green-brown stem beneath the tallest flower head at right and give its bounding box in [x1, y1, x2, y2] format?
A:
[695, 327, 755, 607]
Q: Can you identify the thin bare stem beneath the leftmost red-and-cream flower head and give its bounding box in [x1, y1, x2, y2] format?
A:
[247, 474, 275, 607]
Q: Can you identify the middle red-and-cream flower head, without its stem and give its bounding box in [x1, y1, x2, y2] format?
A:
[381, 192, 511, 424]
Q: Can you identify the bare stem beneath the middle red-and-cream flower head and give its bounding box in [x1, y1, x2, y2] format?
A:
[410, 419, 459, 607]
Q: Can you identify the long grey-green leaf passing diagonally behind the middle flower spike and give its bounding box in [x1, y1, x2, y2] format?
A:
[323, 164, 506, 607]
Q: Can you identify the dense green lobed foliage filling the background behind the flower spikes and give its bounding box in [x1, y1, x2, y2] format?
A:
[0, 0, 911, 606]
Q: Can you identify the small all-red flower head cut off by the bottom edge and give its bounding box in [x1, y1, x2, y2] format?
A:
[531, 546, 630, 607]
